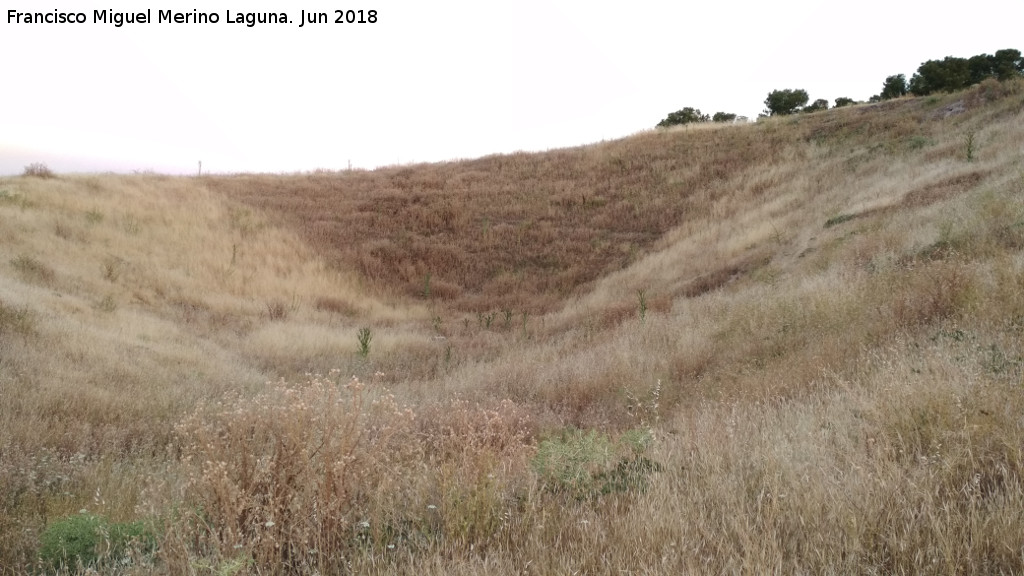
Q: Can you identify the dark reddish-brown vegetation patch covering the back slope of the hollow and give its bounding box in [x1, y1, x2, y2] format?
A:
[209, 124, 798, 312]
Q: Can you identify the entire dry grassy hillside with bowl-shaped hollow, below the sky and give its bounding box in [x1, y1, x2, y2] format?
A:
[0, 78, 1024, 574]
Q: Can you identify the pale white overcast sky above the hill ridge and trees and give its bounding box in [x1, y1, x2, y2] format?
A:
[0, 0, 1024, 174]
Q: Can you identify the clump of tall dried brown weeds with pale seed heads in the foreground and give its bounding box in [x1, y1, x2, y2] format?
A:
[154, 372, 529, 573]
